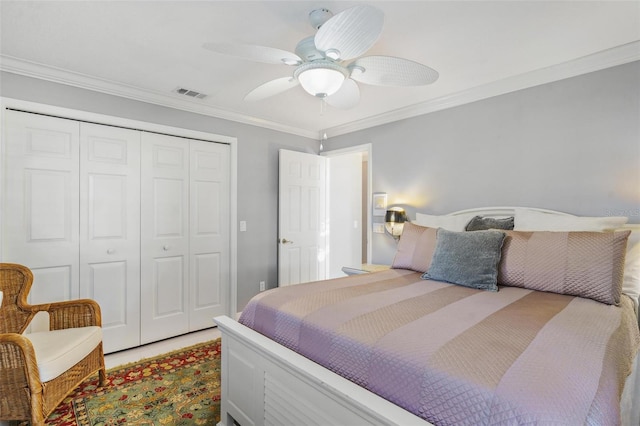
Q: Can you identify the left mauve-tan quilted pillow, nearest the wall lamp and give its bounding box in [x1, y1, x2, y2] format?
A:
[391, 222, 437, 272]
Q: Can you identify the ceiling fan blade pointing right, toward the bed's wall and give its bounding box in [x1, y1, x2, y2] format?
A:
[347, 56, 439, 86]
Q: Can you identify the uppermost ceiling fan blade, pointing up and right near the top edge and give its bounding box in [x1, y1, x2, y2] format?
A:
[314, 5, 384, 61]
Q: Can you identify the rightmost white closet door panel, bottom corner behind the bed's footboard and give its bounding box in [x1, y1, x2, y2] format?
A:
[189, 141, 230, 331]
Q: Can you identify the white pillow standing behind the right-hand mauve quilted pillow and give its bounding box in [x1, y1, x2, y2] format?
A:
[514, 209, 629, 231]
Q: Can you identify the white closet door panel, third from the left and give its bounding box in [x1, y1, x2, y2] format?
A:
[140, 133, 189, 344]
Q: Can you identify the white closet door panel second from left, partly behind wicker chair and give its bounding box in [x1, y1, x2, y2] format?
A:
[80, 123, 140, 352]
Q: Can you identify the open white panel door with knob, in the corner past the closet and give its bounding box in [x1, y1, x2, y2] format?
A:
[278, 149, 327, 286]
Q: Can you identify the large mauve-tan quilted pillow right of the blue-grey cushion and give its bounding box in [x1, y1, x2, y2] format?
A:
[498, 231, 630, 305]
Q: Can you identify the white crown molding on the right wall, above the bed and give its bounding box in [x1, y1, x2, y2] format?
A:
[318, 41, 640, 137]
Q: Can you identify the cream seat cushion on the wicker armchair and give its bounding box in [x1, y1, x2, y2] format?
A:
[24, 326, 102, 382]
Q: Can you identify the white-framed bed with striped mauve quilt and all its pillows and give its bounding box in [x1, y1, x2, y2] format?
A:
[215, 207, 640, 426]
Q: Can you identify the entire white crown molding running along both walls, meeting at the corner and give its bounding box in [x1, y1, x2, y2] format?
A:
[0, 41, 640, 139]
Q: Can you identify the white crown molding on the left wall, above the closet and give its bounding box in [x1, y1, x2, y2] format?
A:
[0, 55, 318, 139]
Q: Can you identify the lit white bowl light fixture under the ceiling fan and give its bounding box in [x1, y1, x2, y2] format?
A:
[293, 61, 348, 98]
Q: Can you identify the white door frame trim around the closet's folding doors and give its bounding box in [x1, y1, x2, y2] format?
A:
[0, 97, 238, 316]
